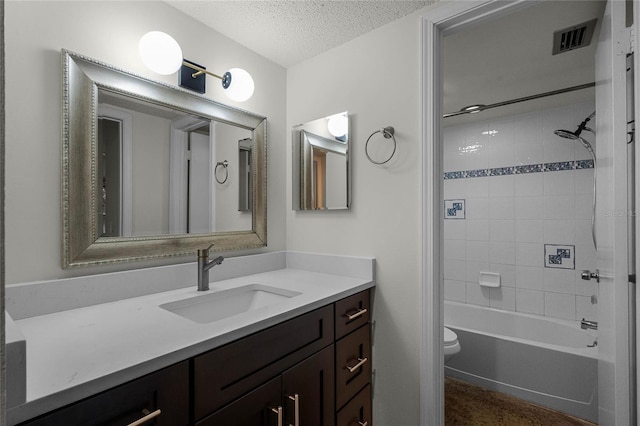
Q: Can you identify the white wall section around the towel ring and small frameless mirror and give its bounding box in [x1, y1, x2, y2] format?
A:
[287, 7, 428, 426]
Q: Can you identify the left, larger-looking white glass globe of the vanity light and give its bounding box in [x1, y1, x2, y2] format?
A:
[138, 31, 182, 75]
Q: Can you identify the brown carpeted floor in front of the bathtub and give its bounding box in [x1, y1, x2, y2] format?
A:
[444, 377, 595, 426]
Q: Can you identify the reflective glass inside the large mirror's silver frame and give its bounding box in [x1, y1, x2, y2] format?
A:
[97, 90, 252, 237]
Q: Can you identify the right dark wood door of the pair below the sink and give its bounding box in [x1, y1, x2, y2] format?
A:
[282, 345, 335, 426]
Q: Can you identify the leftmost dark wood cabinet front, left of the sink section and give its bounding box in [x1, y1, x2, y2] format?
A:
[22, 361, 189, 426]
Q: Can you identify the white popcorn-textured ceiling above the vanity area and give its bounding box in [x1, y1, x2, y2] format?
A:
[167, 0, 433, 67]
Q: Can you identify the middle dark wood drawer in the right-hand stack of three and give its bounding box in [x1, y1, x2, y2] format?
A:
[336, 324, 371, 408]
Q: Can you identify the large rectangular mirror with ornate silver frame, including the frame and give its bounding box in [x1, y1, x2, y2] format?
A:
[62, 51, 267, 268]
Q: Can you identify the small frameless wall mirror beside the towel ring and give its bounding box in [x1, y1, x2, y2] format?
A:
[291, 112, 351, 210]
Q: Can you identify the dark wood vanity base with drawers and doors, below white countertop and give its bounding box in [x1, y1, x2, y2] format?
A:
[17, 290, 372, 426]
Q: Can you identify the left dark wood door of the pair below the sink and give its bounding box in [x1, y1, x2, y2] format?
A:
[197, 376, 284, 426]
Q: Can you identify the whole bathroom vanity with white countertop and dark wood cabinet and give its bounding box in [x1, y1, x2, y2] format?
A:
[9, 251, 373, 426]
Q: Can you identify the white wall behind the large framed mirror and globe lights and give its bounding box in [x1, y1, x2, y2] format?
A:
[4, 1, 288, 284]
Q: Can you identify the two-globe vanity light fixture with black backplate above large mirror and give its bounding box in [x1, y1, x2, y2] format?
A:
[138, 31, 255, 102]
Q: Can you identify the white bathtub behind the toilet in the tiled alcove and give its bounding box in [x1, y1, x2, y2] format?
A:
[444, 301, 598, 422]
